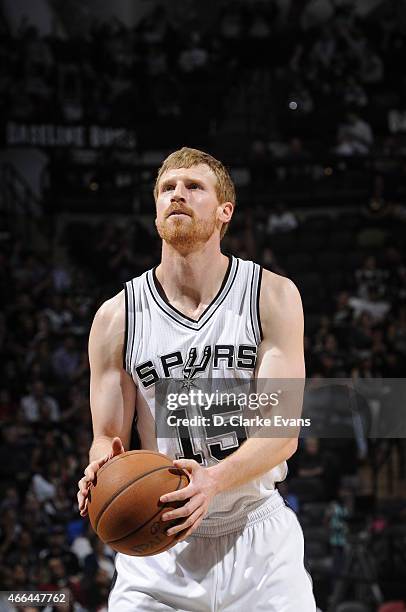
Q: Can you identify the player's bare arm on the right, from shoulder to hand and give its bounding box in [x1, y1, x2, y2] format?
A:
[161, 270, 305, 538]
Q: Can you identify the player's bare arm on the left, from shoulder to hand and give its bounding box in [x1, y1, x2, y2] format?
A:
[78, 292, 136, 515]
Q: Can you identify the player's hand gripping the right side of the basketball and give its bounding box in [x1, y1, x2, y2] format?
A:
[160, 459, 219, 541]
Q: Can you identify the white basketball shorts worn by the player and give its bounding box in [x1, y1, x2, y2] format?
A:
[108, 490, 316, 612]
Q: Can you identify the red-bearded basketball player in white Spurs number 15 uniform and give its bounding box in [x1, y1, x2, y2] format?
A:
[78, 148, 316, 612]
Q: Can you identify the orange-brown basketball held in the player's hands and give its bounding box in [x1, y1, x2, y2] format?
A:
[88, 450, 189, 557]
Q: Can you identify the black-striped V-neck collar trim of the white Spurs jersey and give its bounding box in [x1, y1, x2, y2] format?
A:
[146, 256, 239, 331]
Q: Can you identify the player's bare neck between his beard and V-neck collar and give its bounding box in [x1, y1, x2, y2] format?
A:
[156, 241, 229, 319]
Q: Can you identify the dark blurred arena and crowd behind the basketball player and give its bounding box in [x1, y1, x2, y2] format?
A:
[0, 0, 406, 612]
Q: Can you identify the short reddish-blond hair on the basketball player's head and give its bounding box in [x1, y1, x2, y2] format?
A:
[154, 147, 236, 239]
